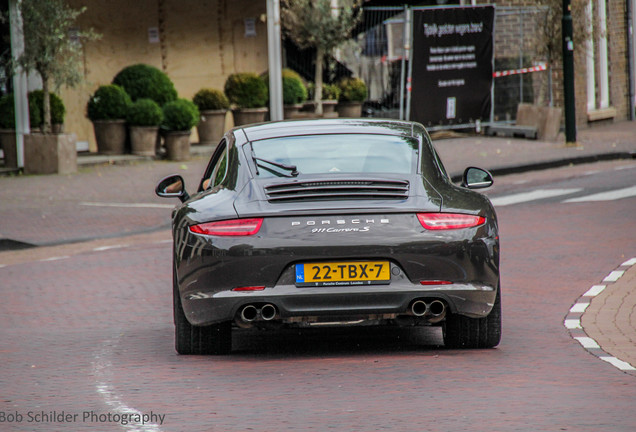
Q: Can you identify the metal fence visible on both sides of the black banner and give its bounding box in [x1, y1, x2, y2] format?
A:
[308, 7, 551, 129]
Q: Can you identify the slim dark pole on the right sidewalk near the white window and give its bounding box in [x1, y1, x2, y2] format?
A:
[561, 0, 576, 144]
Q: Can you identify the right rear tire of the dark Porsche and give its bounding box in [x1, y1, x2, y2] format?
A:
[442, 288, 501, 349]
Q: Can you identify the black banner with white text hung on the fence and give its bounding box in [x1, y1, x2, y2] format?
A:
[410, 6, 495, 126]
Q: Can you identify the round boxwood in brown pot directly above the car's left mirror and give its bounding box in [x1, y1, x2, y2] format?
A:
[161, 99, 200, 160]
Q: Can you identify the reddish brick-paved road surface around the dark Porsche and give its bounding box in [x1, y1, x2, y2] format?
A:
[0, 161, 636, 432]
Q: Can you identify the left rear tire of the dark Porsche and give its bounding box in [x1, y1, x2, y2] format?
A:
[173, 266, 232, 355]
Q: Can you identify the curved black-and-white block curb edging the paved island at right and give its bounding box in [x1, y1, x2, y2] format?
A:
[563, 258, 636, 377]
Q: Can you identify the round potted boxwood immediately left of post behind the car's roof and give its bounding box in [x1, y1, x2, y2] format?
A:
[223, 72, 268, 125]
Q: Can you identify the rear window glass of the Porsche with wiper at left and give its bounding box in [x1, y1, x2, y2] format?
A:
[251, 134, 419, 177]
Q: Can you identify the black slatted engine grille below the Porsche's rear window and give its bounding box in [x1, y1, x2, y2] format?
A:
[265, 180, 409, 203]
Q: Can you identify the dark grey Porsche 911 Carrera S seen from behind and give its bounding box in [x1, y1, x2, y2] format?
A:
[156, 119, 501, 354]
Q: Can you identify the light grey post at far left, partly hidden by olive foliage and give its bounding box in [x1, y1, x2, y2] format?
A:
[9, 0, 31, 168]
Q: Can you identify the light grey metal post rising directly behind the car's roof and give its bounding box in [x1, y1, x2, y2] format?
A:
[267, 0, 283, 121]
